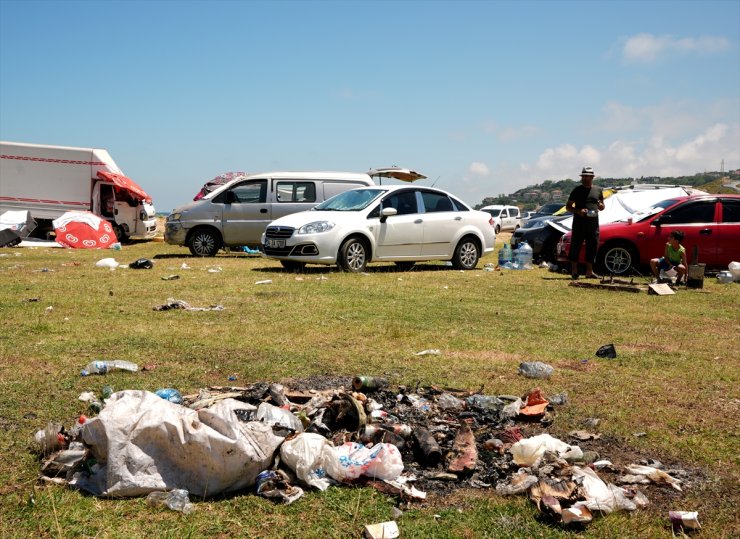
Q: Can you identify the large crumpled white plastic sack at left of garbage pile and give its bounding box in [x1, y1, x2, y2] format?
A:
[70, 390, 283, 497]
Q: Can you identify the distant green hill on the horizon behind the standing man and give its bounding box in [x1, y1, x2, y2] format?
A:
[475, 170, 740, 211]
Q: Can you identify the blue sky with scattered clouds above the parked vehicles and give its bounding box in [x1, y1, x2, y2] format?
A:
[0, 0, 740, 212]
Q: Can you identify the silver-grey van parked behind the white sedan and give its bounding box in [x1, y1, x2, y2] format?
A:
[164, 172, 375, 256]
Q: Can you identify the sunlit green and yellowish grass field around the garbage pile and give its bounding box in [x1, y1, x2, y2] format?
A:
[0, 240, 740, 538]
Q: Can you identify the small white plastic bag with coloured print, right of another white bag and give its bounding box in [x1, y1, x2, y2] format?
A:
[332, 442, 403, 481]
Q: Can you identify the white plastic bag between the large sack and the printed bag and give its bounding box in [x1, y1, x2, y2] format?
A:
[280, 432, 342, 490]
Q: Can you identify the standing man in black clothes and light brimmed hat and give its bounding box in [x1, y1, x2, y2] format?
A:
[565, 167, 604, 279]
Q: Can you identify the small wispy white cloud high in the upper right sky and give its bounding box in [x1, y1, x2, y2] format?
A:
[622, 33, 730, 63]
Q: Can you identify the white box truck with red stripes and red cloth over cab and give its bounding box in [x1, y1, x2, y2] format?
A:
[0, 141, 157, 242]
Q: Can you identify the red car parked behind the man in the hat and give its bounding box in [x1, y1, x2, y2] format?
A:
[557, 195, 740, 275]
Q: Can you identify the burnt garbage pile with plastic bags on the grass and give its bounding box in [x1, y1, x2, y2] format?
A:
[36, 376, 683, 524]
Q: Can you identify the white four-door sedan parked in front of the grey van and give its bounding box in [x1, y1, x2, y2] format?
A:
[262, 185, 496, 272]
